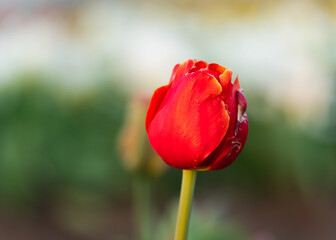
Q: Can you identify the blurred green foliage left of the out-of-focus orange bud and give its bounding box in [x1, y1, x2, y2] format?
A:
[0, 75, 127, 207]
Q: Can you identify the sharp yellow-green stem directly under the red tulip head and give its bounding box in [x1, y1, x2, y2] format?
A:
[175, 169, 197, 240]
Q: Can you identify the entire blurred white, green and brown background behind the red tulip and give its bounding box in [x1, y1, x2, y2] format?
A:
[0, 0, 336, 240]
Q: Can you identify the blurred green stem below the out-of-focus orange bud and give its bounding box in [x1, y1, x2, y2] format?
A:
[133, 176, 151, 240]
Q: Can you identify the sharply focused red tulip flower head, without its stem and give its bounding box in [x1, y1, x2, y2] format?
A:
[146, 60, 248, 170]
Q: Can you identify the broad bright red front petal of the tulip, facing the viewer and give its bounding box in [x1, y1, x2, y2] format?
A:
[147, 71, 230, 169]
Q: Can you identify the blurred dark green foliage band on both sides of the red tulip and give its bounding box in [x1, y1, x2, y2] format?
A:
[0, 75, 336, 210]
